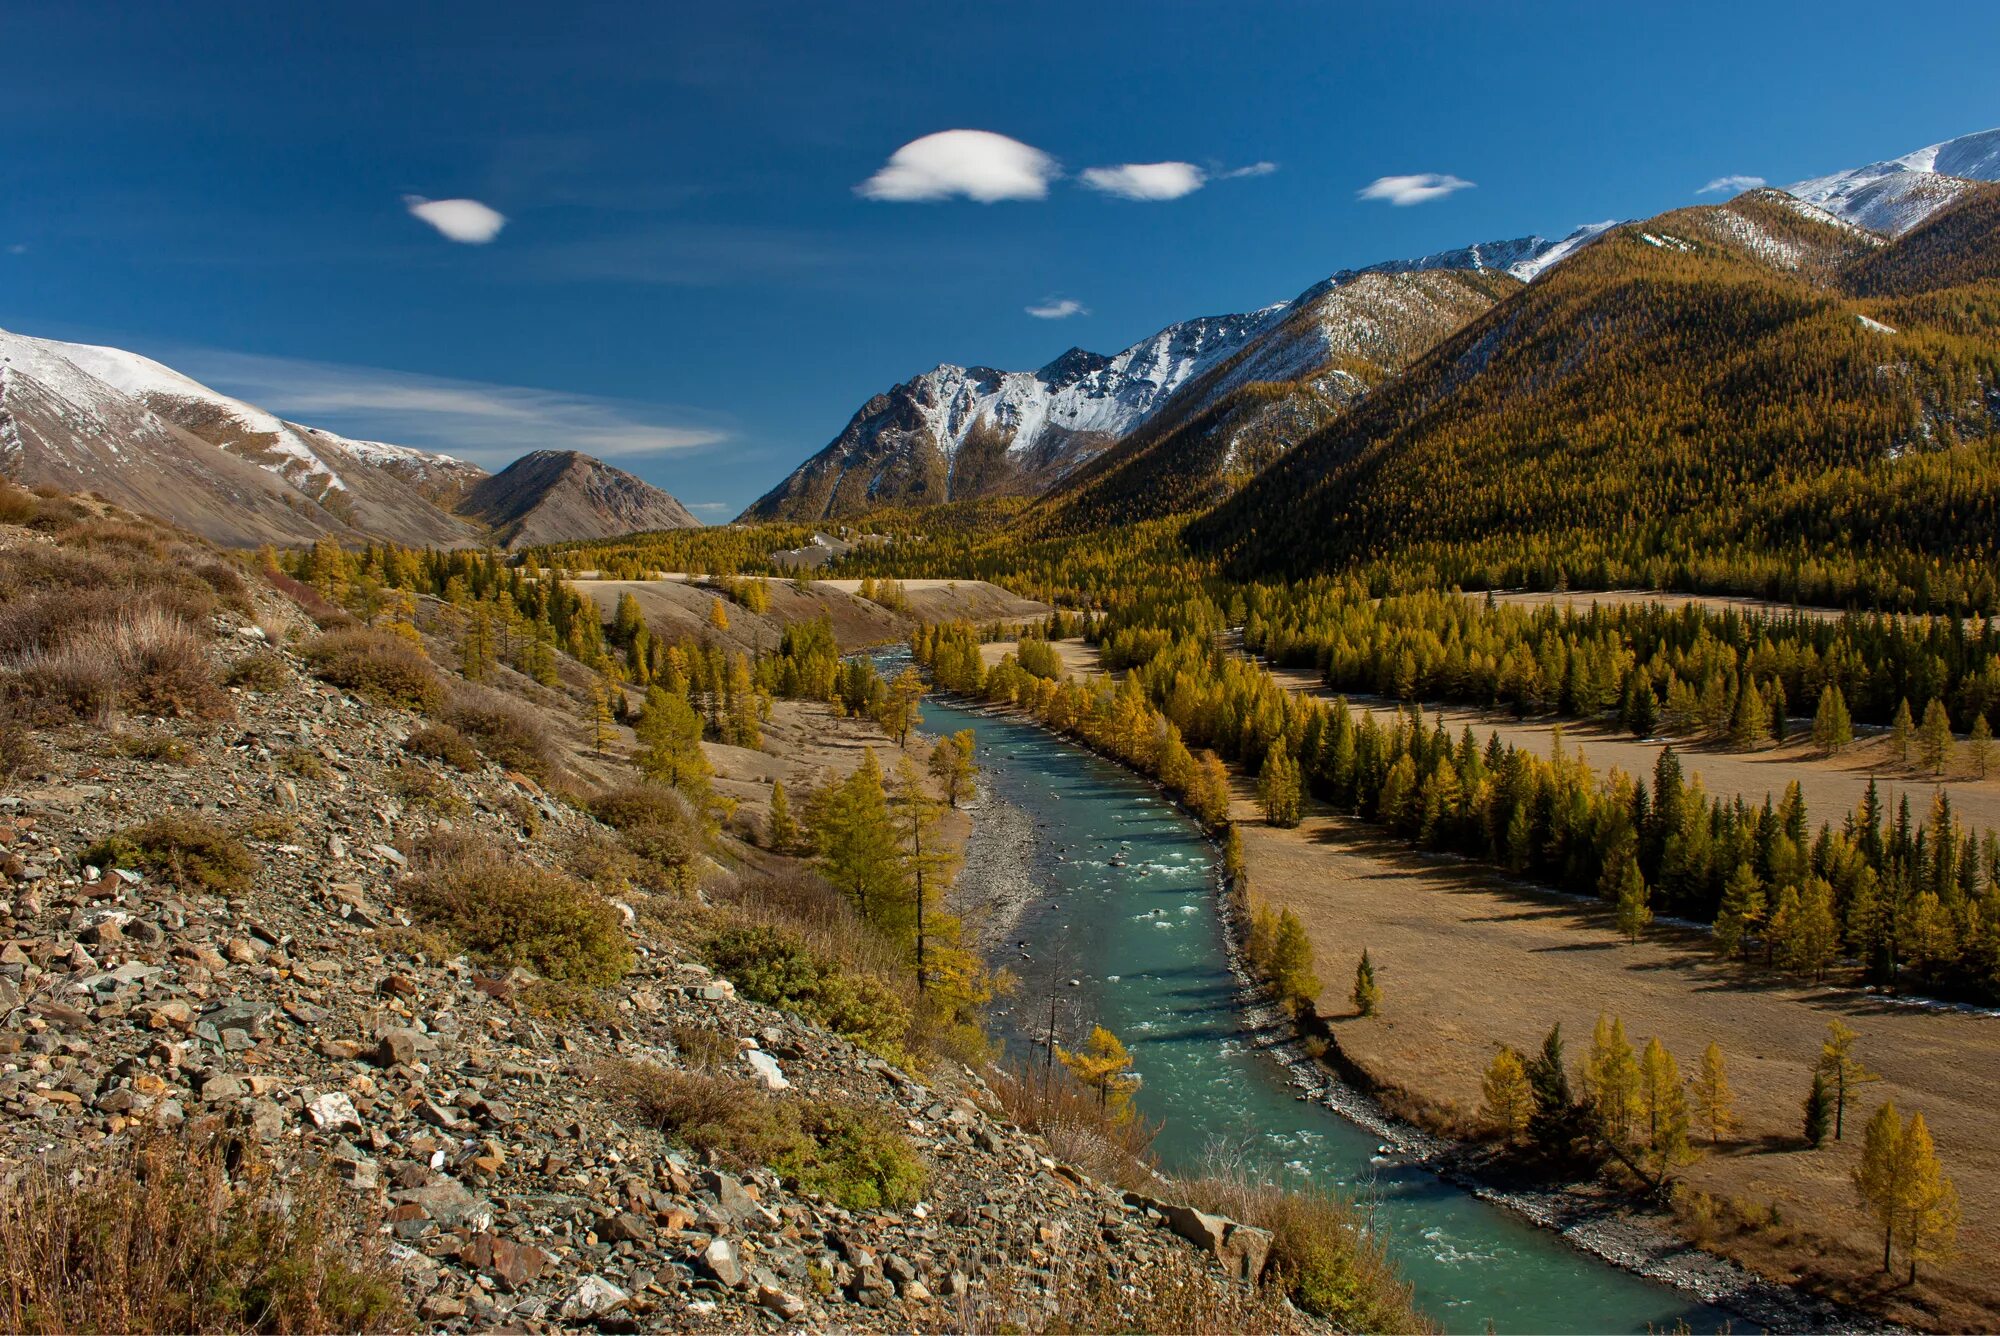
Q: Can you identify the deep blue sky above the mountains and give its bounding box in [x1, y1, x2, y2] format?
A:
[0, 0, 2000, 520]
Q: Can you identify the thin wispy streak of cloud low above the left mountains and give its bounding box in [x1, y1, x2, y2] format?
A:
[170, 348, 728, 468]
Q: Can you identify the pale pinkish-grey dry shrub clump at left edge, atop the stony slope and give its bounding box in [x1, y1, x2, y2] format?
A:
[6, 606, 230, 722]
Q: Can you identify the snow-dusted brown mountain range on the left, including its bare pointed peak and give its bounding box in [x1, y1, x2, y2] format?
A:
[0, 330, 698, 546]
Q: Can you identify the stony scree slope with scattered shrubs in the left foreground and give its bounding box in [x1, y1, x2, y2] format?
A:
[0, 496, 1344, 1332]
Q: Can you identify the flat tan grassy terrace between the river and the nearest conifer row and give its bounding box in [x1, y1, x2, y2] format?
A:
[1236, 782, 2000, 1328]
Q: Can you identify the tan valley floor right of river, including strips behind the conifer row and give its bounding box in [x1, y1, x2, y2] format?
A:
[986, 642, 2000, 1330]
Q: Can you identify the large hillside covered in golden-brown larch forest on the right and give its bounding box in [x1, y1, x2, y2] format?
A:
[1188, 188, 2000, 610]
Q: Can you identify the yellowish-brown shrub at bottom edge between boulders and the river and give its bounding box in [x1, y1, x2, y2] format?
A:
[1174, 1168, 1432, 1332]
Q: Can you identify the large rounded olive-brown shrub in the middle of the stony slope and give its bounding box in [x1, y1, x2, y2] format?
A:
[404, 840, 632, 988]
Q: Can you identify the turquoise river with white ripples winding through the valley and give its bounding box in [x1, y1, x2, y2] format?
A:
[924, 700, 1748, 1332]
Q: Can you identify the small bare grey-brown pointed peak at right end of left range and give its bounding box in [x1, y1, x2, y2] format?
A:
[458, 450, 700, 548]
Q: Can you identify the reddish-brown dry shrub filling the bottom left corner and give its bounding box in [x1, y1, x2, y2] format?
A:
[0, 1136, 410, 1332]
